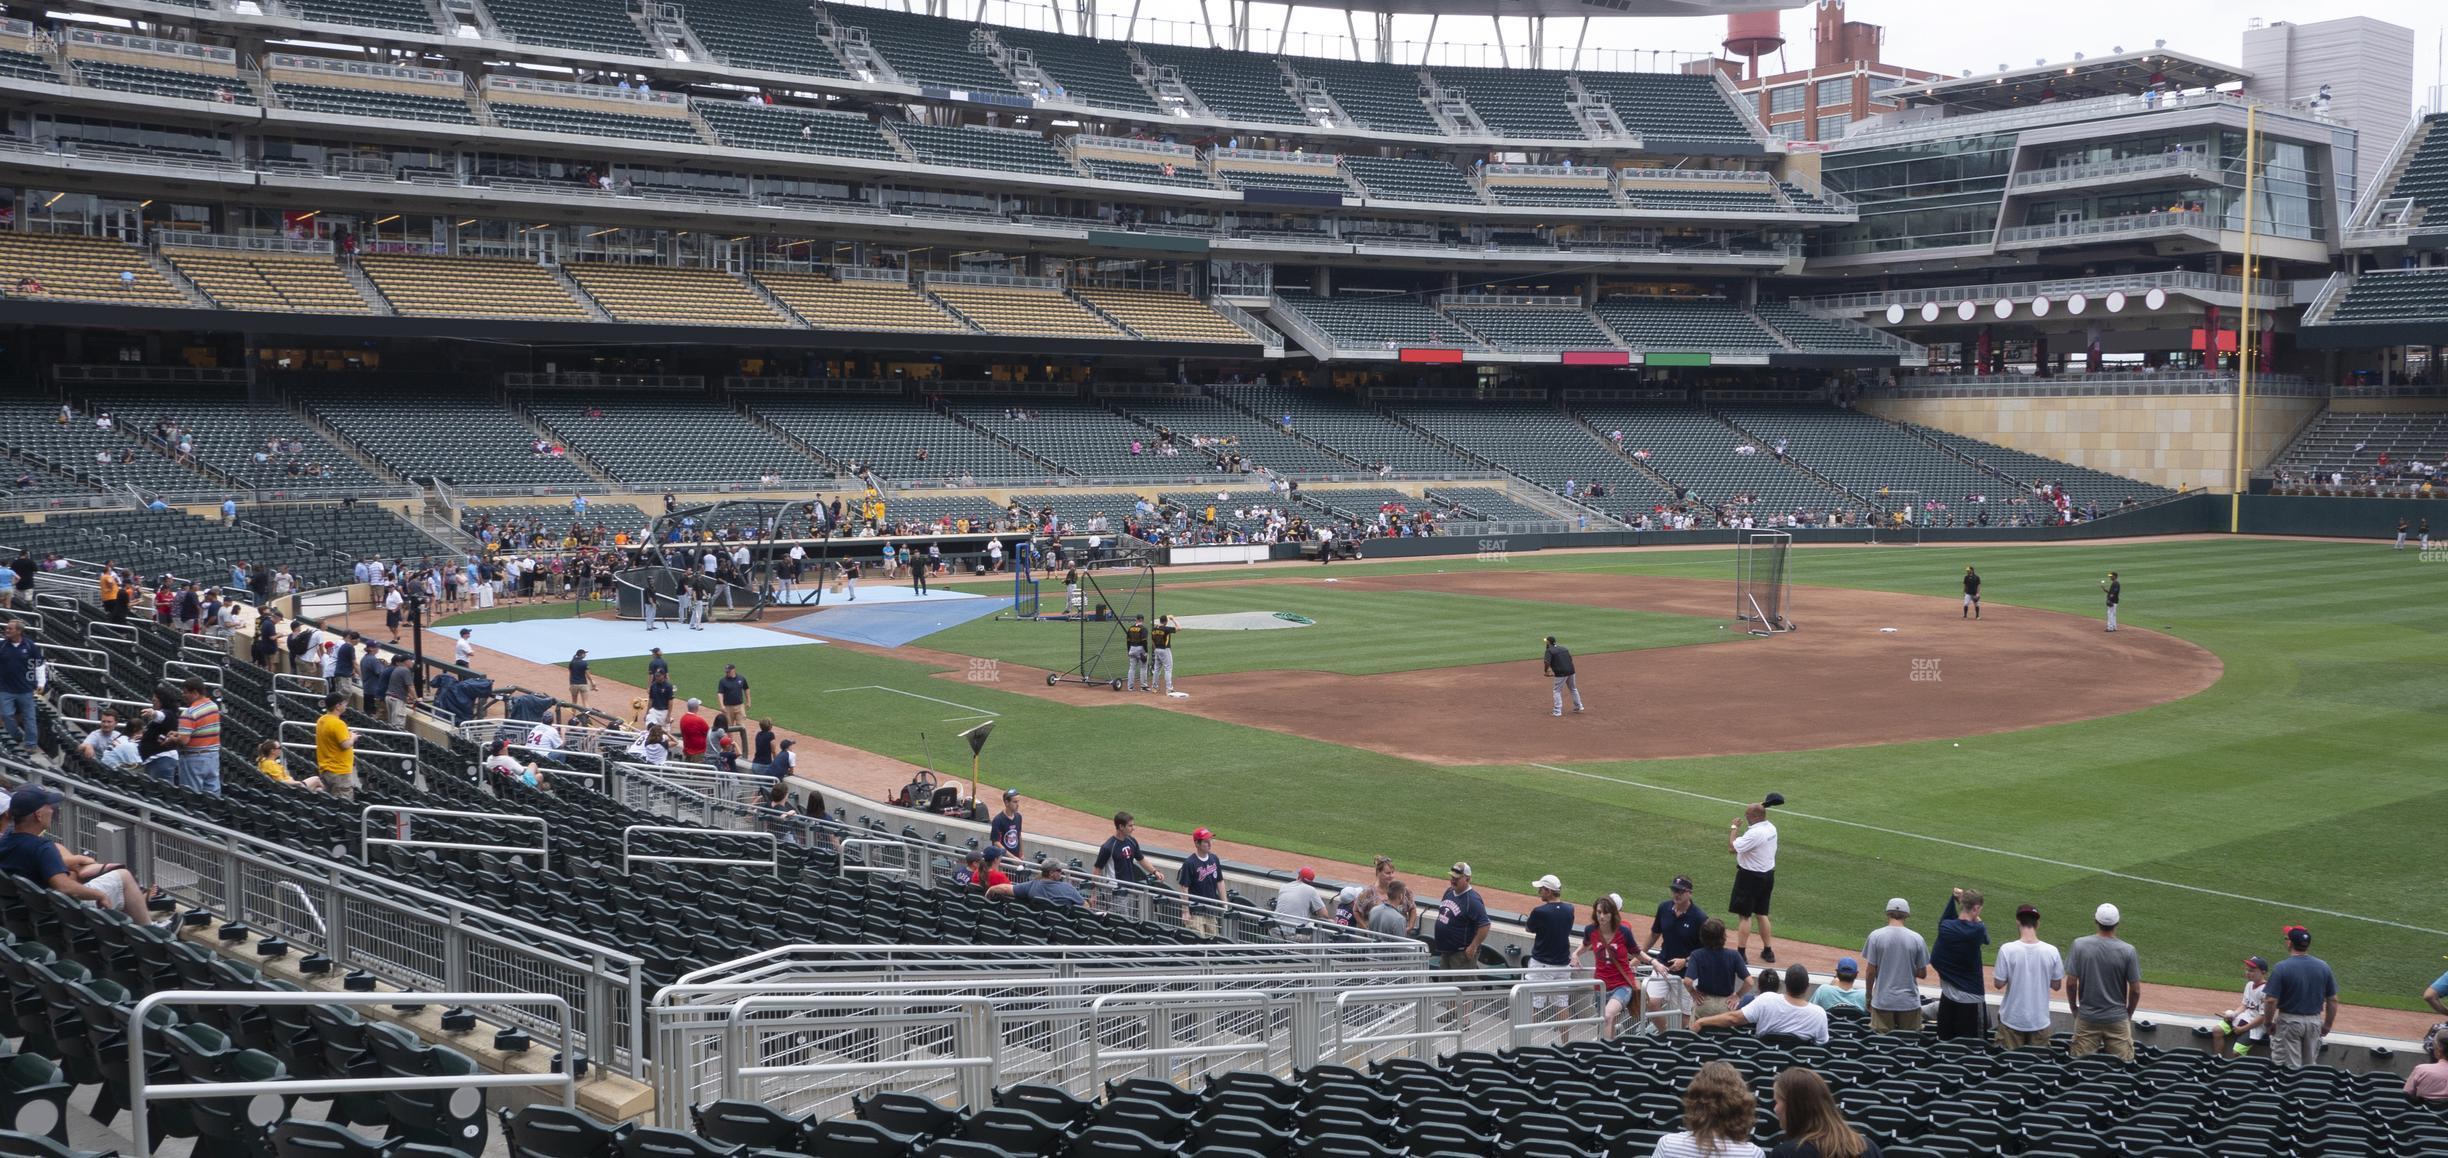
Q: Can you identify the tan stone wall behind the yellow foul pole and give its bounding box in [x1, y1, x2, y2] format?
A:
[1860, 394, 2326, 492]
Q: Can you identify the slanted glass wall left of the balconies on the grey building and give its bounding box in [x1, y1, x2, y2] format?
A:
[1812, 135, 2015, 257]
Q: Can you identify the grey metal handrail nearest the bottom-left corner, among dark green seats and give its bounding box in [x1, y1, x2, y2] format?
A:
[127, 989, 578, 1138]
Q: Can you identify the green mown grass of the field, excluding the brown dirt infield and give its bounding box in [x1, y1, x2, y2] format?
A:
[600, 541, 2448, 1009]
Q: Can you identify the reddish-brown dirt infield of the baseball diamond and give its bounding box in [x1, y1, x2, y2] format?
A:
[903, 570, 2223, 764]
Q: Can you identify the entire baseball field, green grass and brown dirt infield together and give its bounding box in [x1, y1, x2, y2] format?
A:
[541, 539, 2448, 1009]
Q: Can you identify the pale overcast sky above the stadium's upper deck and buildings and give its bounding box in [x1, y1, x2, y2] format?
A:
[920, 0, 2448, 105]
